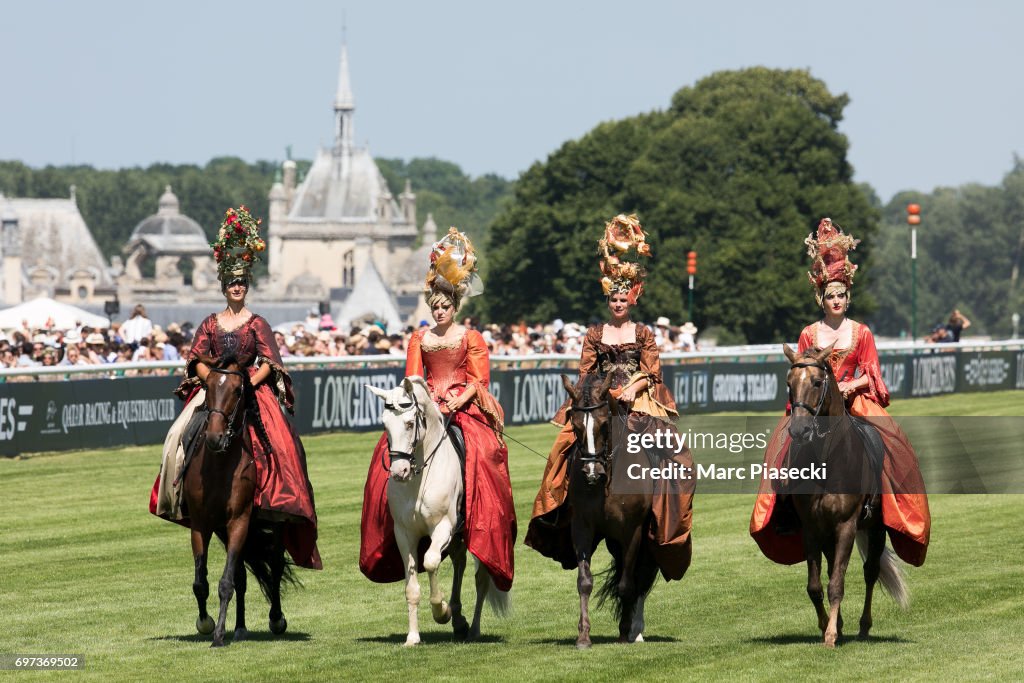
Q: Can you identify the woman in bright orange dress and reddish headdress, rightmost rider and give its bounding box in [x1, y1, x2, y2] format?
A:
[751, 218, 931, 566]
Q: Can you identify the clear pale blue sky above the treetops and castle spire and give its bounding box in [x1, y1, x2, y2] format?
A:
[0, 0, 1024, 200]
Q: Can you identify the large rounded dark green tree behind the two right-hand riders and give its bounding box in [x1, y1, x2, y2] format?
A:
[486, 68, 878, 342]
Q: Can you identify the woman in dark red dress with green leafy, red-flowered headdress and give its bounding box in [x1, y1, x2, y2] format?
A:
[150, 207, 323, 569]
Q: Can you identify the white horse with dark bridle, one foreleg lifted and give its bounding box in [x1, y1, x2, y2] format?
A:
[367, 376, 509, 645]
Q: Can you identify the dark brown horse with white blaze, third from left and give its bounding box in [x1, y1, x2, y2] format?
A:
[562, 374, 658, 649]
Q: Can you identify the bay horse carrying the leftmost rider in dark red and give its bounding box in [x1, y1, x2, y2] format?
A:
[182, 355, 295, 647]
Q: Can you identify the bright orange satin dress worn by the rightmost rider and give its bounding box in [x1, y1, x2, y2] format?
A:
[751, 322, 932, 566]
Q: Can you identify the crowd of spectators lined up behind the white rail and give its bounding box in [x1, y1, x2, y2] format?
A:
[0, 305, 696, 377]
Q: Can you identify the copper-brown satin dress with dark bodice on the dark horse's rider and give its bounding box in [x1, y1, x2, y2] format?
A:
[524, 325, 693, 581]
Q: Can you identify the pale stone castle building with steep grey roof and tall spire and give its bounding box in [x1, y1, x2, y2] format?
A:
[265, 45, 436, 325]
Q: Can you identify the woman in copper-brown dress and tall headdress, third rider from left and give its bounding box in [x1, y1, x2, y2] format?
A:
[525, 215, 693, 580]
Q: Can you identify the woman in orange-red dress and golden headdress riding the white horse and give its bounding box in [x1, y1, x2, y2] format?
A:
[359, 227, 516, 591]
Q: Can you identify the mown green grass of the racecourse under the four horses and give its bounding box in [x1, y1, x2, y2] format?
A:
[0, 392, 1024, 681]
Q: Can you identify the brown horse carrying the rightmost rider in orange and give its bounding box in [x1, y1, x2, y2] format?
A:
[782, 343, 909, 647]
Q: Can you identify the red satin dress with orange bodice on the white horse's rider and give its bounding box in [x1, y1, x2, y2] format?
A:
[359, 330, 516, 591]
